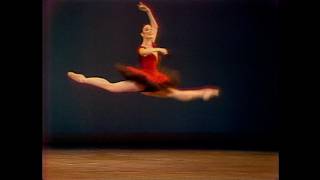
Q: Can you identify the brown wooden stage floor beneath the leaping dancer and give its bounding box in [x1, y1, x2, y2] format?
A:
[43, 149, 279, 180]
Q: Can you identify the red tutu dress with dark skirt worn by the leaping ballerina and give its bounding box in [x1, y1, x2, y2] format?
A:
[117, 43, 178, 91]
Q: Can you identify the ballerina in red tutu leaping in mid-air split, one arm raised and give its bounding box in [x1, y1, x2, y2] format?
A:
[67, 2, 219, 101]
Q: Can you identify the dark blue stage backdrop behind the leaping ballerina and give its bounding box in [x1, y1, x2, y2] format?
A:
[44, 0, 279, 143]
